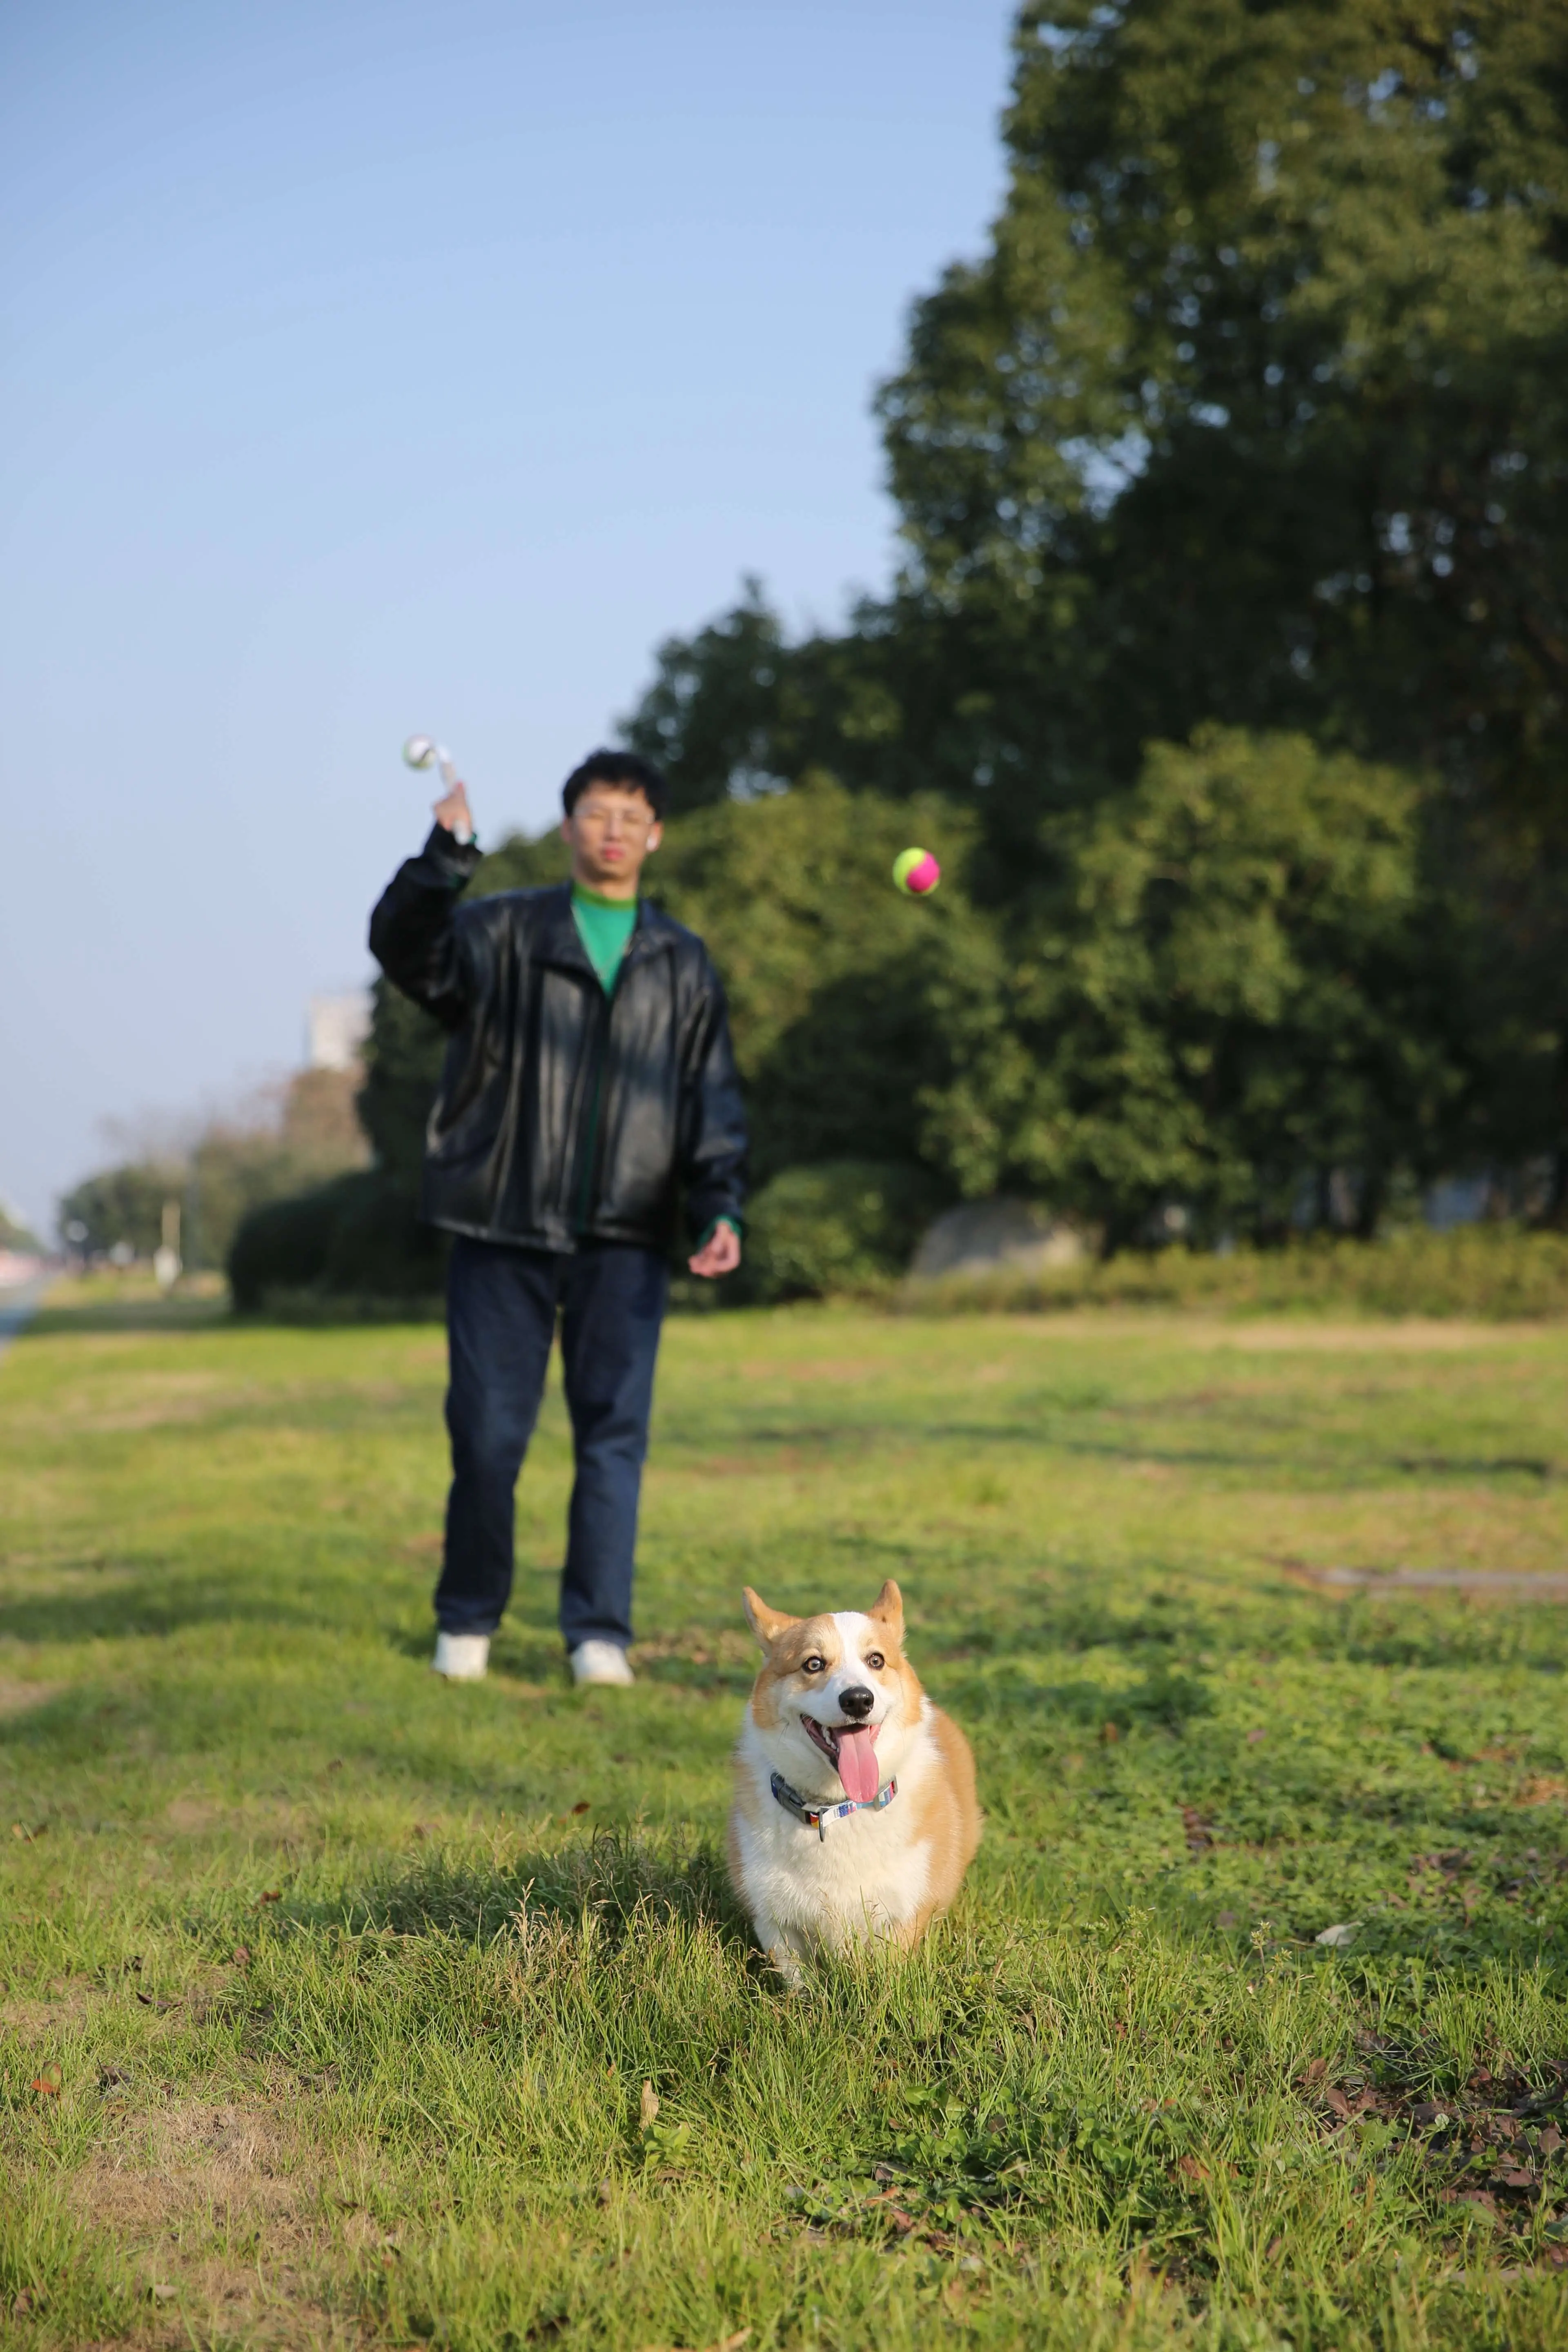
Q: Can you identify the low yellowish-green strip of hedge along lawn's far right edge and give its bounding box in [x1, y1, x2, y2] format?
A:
[898, 1225, 1568, 1319]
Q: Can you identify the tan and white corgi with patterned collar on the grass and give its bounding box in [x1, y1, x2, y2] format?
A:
[729, 1578, 980, 1983]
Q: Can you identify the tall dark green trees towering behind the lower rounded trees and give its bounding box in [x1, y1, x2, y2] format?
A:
[611, 0, 1568, 1195]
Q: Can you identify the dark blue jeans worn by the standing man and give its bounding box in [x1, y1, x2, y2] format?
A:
[435, 1237, 670, 1649]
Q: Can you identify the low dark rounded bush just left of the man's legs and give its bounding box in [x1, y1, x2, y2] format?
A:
[228, 1169, 444, 1315]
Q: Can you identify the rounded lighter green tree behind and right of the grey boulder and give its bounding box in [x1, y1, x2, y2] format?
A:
[924, 727, 1472, 1247]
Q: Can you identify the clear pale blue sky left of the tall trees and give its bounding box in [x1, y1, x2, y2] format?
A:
[0, 0, 1011, 1230]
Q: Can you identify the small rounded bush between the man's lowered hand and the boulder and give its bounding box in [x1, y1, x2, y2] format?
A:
[745, 1160, 945, 1301]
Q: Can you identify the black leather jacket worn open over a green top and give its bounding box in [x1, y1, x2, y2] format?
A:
[369, 826, 745, 1249]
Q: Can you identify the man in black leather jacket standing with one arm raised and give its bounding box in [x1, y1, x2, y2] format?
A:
[369, 750, 745, 1684]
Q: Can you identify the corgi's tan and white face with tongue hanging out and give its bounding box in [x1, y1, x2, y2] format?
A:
[745, 1578, 924, 1804]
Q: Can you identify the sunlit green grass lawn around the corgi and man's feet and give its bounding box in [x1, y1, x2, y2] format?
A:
[0, 1298, 1568, 2352]
